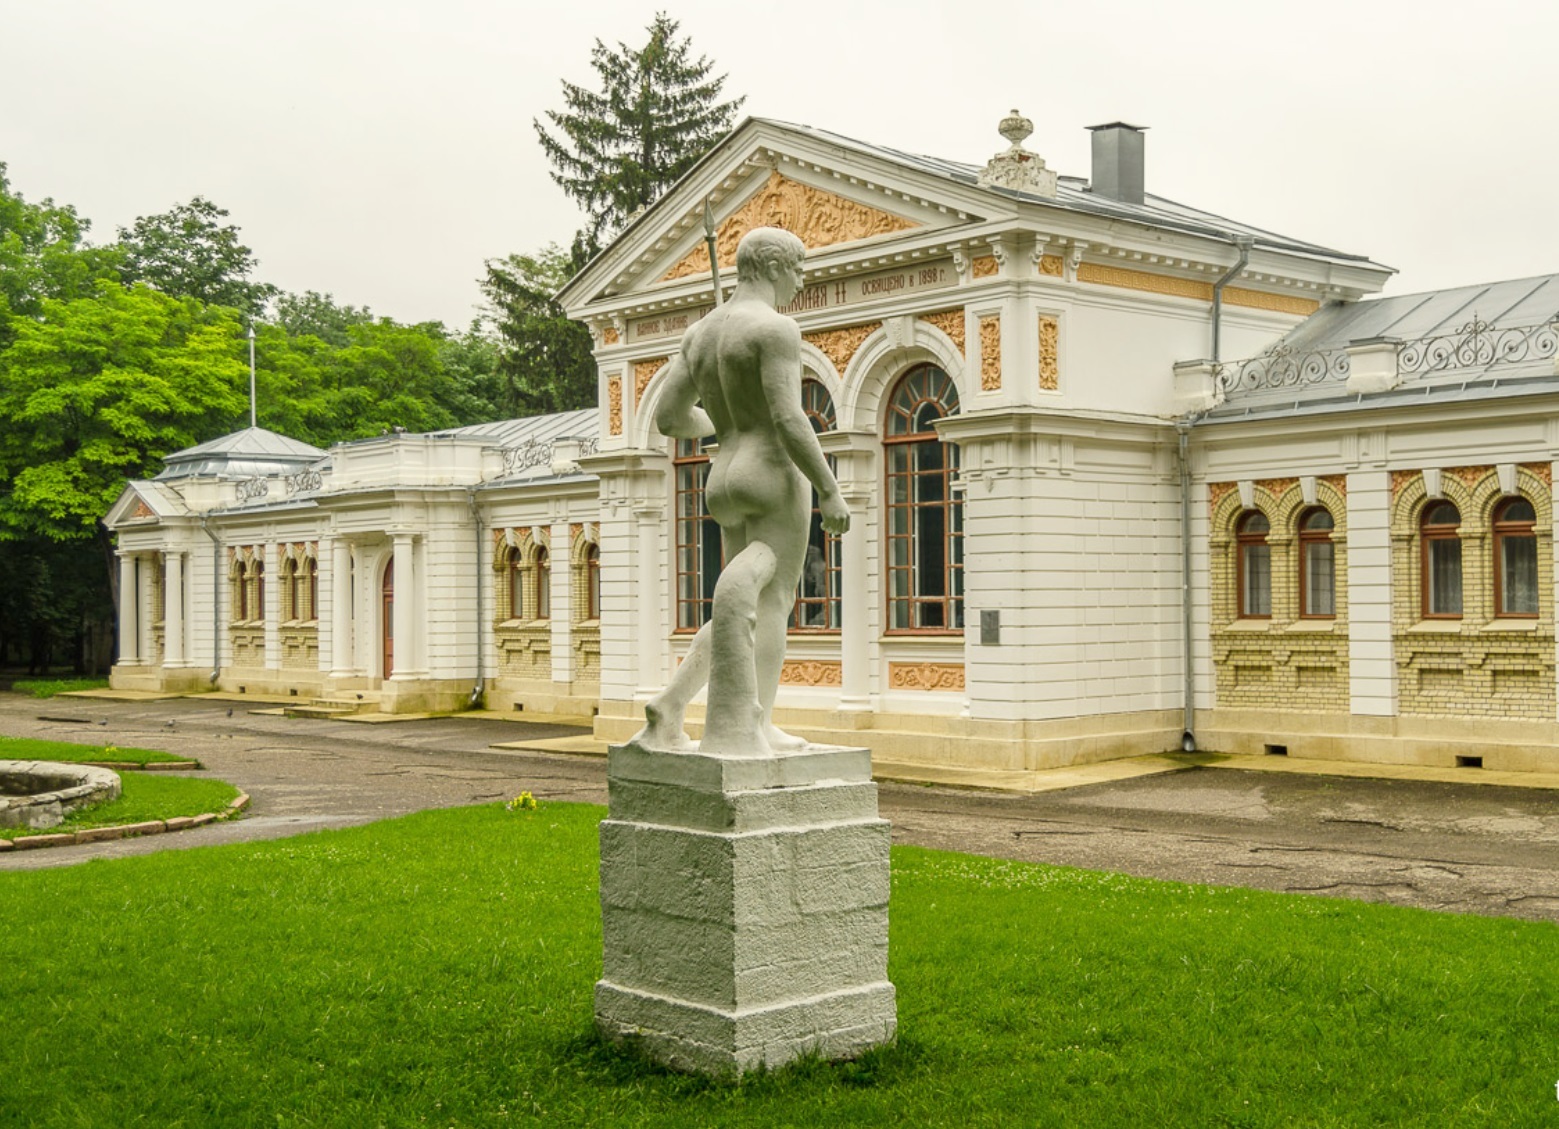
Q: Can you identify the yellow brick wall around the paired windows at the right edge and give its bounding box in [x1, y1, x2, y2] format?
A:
[1391, 463, 1554, 720]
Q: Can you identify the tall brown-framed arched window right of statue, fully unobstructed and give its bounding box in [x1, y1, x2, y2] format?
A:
[882, 365, 963, 632]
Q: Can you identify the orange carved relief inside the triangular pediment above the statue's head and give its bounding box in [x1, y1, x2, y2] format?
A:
[661, 172, 920, 282]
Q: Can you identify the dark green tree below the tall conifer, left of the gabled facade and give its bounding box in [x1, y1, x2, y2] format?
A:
[482, 245, 596, 418]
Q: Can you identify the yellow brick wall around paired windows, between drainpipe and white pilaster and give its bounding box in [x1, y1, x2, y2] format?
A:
[1208, 476, 1349, 711]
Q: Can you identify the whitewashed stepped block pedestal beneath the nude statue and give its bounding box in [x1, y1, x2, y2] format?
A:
[596, 744, 898, 1074]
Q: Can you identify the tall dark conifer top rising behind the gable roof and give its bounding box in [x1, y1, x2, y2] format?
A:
[532, 12, 745, 255]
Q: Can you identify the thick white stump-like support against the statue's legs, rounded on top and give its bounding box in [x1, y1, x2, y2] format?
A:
[698, 540, 775, 756]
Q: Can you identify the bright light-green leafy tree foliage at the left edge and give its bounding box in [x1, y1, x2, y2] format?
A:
[0, 281, 246, 541]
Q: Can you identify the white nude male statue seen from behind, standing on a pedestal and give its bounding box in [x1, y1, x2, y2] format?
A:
[635, 228, 850, 756]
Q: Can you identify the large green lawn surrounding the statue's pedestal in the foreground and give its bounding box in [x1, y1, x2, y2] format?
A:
[0, 803, 1559, 1129]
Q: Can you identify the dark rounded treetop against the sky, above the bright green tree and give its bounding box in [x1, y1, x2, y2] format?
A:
[118, 196, 278, 315]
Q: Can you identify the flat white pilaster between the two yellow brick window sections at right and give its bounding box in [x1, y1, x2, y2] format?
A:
[1349, 471, 1397, 717]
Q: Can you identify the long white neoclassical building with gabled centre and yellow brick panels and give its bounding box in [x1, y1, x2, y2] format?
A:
[108, 119, 1559, 773]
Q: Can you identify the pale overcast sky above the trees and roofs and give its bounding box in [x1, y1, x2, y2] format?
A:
[0, 0, 1559, 324]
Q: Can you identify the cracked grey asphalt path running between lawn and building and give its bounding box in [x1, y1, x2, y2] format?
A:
[0, 692, 1559, 922]
